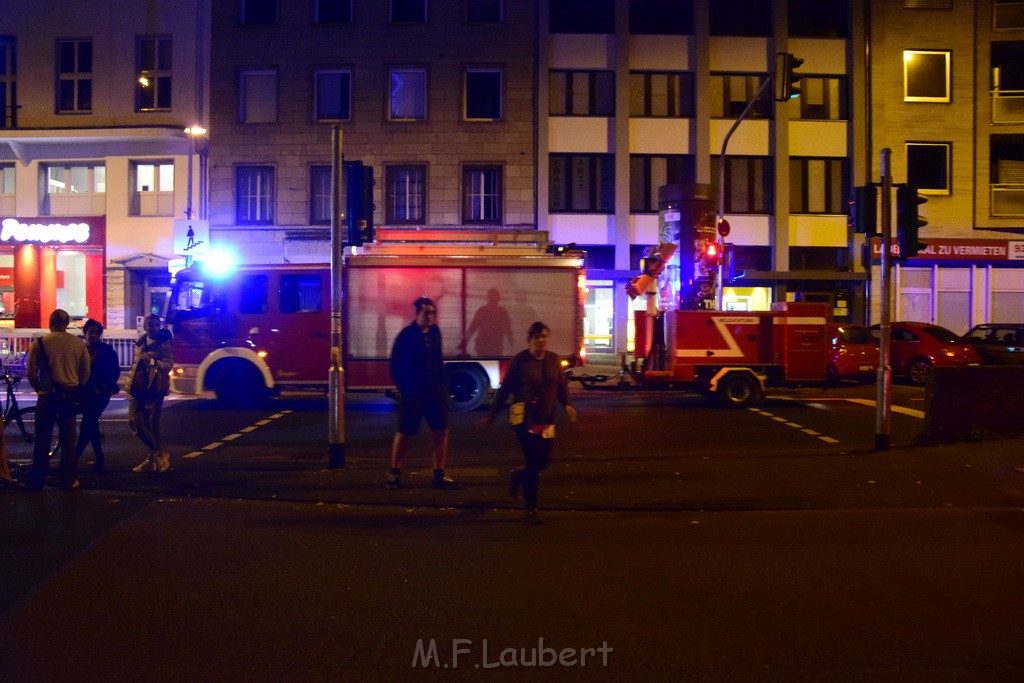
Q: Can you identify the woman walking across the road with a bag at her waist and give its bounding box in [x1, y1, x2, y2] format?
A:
[481, 323, 577, 524]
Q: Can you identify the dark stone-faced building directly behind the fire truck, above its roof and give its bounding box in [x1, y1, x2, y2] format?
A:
[209, 0, 537, 262]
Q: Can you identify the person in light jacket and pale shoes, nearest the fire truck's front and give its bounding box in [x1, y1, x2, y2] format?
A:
[128, 313, 174, 472]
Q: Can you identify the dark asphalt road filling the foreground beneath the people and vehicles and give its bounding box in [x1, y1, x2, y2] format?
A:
[0, 387, 1024, 681]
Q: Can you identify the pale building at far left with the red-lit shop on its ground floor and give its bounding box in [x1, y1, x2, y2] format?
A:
[0, 0, 210, 328]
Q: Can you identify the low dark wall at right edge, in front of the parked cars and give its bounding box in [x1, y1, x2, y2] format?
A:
[922, 366, 1024, 443]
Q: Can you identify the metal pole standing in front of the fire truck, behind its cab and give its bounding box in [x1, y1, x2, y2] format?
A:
[327, 124, 345, 469]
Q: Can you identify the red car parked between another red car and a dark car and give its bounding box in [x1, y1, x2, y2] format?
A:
[871, 323, 981, 384]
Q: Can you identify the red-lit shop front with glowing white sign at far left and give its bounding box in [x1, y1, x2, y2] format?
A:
[0, 216, 106, 329]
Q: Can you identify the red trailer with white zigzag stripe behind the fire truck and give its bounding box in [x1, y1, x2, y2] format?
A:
[634, 302, 831, 408]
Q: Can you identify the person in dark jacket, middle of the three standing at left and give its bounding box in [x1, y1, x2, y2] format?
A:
[75, 319, 121, 473]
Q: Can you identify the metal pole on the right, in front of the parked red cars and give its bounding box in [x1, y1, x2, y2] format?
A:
[874, 147, 893, 451]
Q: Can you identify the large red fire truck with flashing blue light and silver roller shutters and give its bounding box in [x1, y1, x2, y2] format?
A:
[167, 229, 585, 411]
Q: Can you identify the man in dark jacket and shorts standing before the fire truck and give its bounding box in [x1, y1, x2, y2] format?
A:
[387, 297, 459, 489]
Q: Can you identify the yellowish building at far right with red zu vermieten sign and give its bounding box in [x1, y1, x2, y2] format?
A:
[857, 0, 1024, 334]
